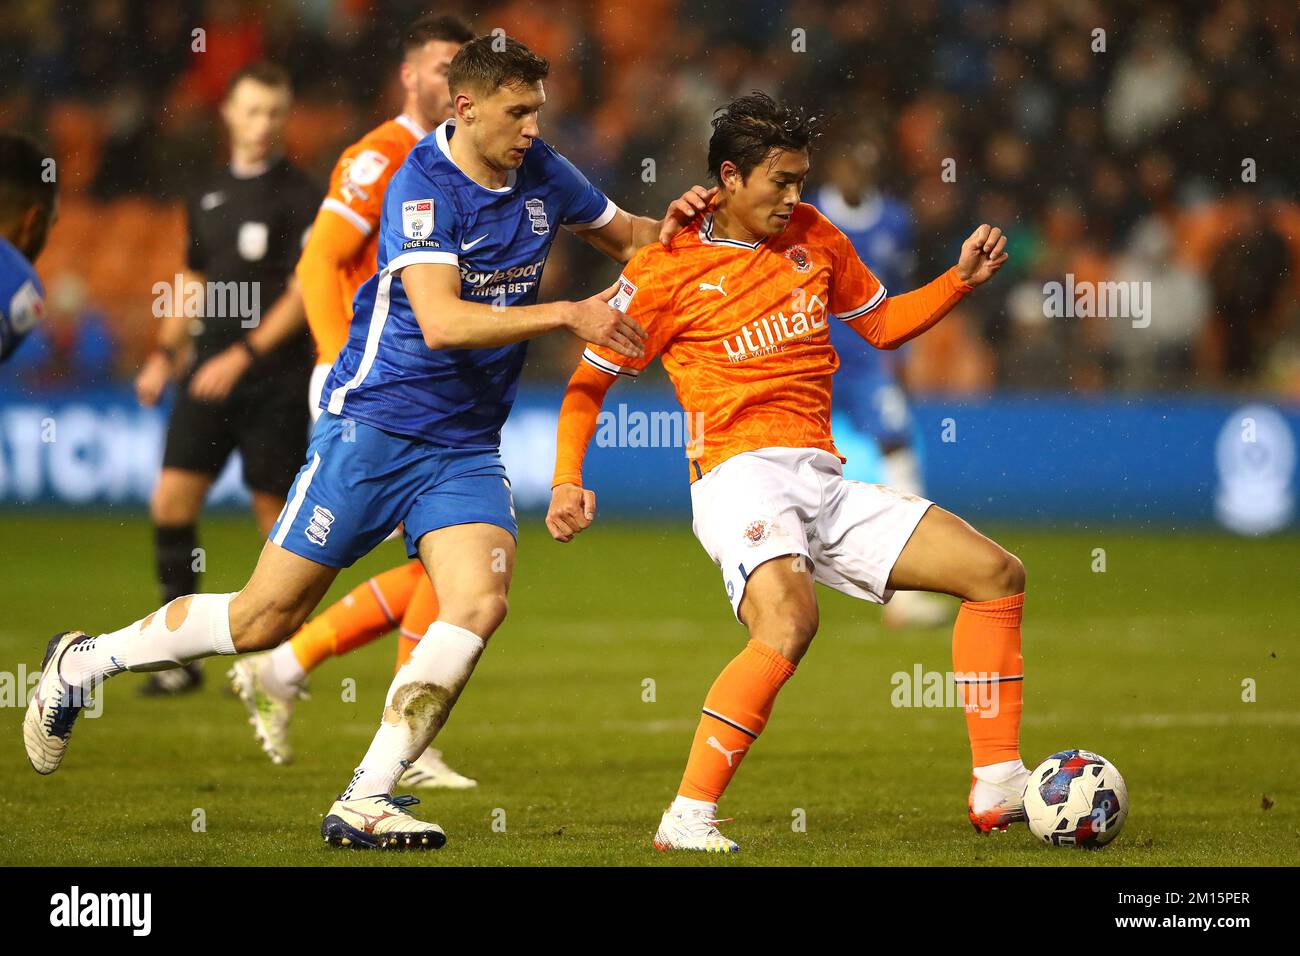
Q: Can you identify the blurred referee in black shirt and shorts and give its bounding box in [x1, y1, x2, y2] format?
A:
[135, 64, 322, 693]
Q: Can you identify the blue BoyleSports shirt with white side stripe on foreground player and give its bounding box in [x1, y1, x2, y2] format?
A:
[321, 120, 618, 447]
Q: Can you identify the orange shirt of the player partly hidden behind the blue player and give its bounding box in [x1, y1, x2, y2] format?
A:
[307, 116, 425, 363]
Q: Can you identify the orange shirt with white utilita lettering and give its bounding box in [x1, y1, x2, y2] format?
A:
[582, 203, 887, 481]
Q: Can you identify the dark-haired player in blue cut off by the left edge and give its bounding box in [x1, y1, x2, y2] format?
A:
[0, 133, 57, 362]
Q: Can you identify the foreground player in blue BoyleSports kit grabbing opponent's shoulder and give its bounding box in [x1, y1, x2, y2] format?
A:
[23, 36, 712, 849]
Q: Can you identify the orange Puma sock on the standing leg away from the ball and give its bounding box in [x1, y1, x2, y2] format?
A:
[677, 640, 794, 804]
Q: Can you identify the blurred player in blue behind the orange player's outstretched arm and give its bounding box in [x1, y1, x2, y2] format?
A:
[811, 133, 956, 628]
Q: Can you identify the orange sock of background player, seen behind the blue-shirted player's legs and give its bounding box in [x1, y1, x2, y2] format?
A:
[290, 561, 425, 671]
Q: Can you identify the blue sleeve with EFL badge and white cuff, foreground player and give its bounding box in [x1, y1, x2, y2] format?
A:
[380, 150, 460, 272]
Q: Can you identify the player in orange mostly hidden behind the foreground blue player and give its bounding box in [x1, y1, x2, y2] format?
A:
[230, 14, 476, 790]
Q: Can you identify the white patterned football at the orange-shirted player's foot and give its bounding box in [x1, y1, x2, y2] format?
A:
[1024, 750, 1128, 849]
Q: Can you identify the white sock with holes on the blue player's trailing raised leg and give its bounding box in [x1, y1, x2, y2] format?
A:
[59, 593, 235, 688]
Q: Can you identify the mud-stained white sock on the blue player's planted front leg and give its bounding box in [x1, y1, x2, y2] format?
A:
[339, 620, 484, 800]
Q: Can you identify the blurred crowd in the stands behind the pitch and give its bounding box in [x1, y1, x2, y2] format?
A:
[0, 0, 1300, 398]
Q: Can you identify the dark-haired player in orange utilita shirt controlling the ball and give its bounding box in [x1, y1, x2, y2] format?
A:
[546, 94, 1028, 853]
